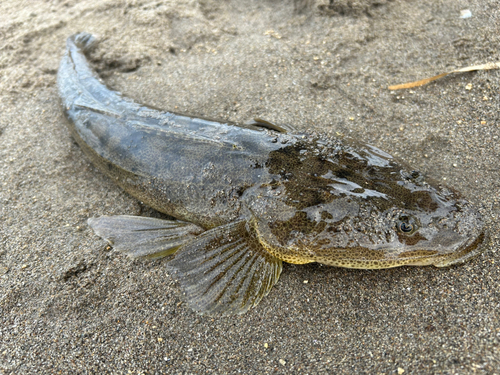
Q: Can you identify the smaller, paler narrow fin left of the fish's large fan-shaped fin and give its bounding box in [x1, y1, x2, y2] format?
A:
[88, 215, 203, 258]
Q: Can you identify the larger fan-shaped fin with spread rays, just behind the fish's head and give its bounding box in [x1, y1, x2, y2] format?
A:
[168, 221, 282, 315]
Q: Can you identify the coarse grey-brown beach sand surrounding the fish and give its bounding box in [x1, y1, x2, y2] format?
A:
[0, 0, 500, 374]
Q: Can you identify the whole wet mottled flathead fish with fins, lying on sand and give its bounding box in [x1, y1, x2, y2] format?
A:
[58, 33, 487, 315]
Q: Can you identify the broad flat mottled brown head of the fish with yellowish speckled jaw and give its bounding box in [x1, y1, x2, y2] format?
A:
[247, 137, 488, 269]
